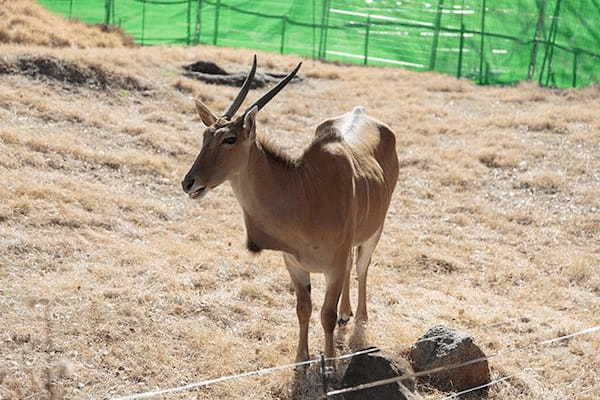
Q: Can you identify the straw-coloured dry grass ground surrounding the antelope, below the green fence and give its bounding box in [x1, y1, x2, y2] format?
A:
[0, 3, 600, 400]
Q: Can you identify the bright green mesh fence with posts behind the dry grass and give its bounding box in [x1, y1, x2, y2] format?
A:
[40, 0, 600, 87]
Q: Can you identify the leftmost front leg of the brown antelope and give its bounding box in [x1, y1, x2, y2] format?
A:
[283, 254, 312, 362]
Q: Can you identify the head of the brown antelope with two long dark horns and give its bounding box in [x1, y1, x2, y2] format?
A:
[181, 56, 302, 199]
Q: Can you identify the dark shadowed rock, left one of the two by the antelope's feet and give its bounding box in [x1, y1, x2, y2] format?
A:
[342, 351, 415, 400]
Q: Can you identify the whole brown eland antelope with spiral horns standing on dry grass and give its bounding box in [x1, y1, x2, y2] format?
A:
[182, 56, 398, 361]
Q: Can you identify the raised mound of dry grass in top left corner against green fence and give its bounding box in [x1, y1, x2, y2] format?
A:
[0, 0, 135, 48]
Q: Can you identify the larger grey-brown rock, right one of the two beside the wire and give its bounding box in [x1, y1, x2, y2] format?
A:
[410, 325, 490, 395]
